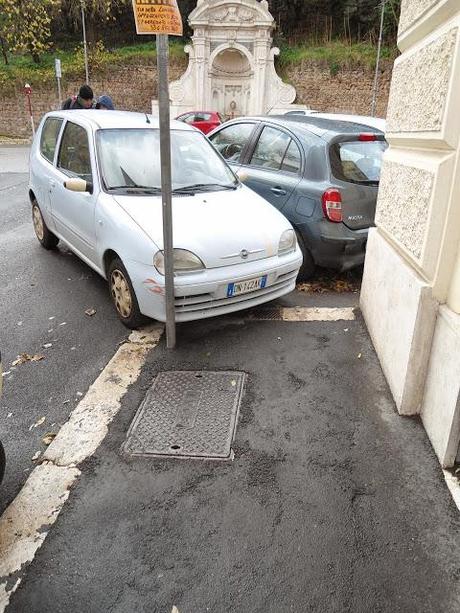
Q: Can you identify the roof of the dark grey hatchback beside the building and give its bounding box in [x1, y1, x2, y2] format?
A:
[246, 115, 383, 140]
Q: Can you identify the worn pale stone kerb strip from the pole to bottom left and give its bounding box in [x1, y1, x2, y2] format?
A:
[0, 325, 163, 613]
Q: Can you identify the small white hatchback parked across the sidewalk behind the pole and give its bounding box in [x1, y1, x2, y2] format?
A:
[29, 110, 302, 328]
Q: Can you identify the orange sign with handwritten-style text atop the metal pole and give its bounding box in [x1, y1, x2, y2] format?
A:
[132, 0, 182, 36]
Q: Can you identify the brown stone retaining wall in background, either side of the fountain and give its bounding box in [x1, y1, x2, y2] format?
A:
[0, 62, 391, 137]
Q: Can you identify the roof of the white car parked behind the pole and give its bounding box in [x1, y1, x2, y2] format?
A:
[48, 109, 195, 132]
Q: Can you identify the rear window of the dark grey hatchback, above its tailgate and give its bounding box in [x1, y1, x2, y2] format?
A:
[330, 140, 388, 185]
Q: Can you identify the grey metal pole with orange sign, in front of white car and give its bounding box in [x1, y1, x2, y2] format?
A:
[132, 0, 182, 349]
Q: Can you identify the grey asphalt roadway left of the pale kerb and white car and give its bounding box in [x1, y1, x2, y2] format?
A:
[0, 147, 127, 513]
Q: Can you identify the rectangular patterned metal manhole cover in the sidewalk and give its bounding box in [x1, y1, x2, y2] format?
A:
[123, 371, 245, 459]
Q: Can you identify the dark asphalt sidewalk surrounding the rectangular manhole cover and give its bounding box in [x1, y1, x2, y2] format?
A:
[8, 315, 460, 613]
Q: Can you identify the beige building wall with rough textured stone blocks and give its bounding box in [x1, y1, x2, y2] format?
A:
[361, 0, 460, 466]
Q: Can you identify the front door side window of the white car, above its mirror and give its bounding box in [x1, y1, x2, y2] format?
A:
[58, 121, 92, 182]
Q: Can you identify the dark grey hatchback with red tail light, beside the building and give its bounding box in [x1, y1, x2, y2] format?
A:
[209, 115, 387, 279]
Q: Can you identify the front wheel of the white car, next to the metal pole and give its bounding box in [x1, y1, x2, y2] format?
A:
[107, 258, 149, 330]
